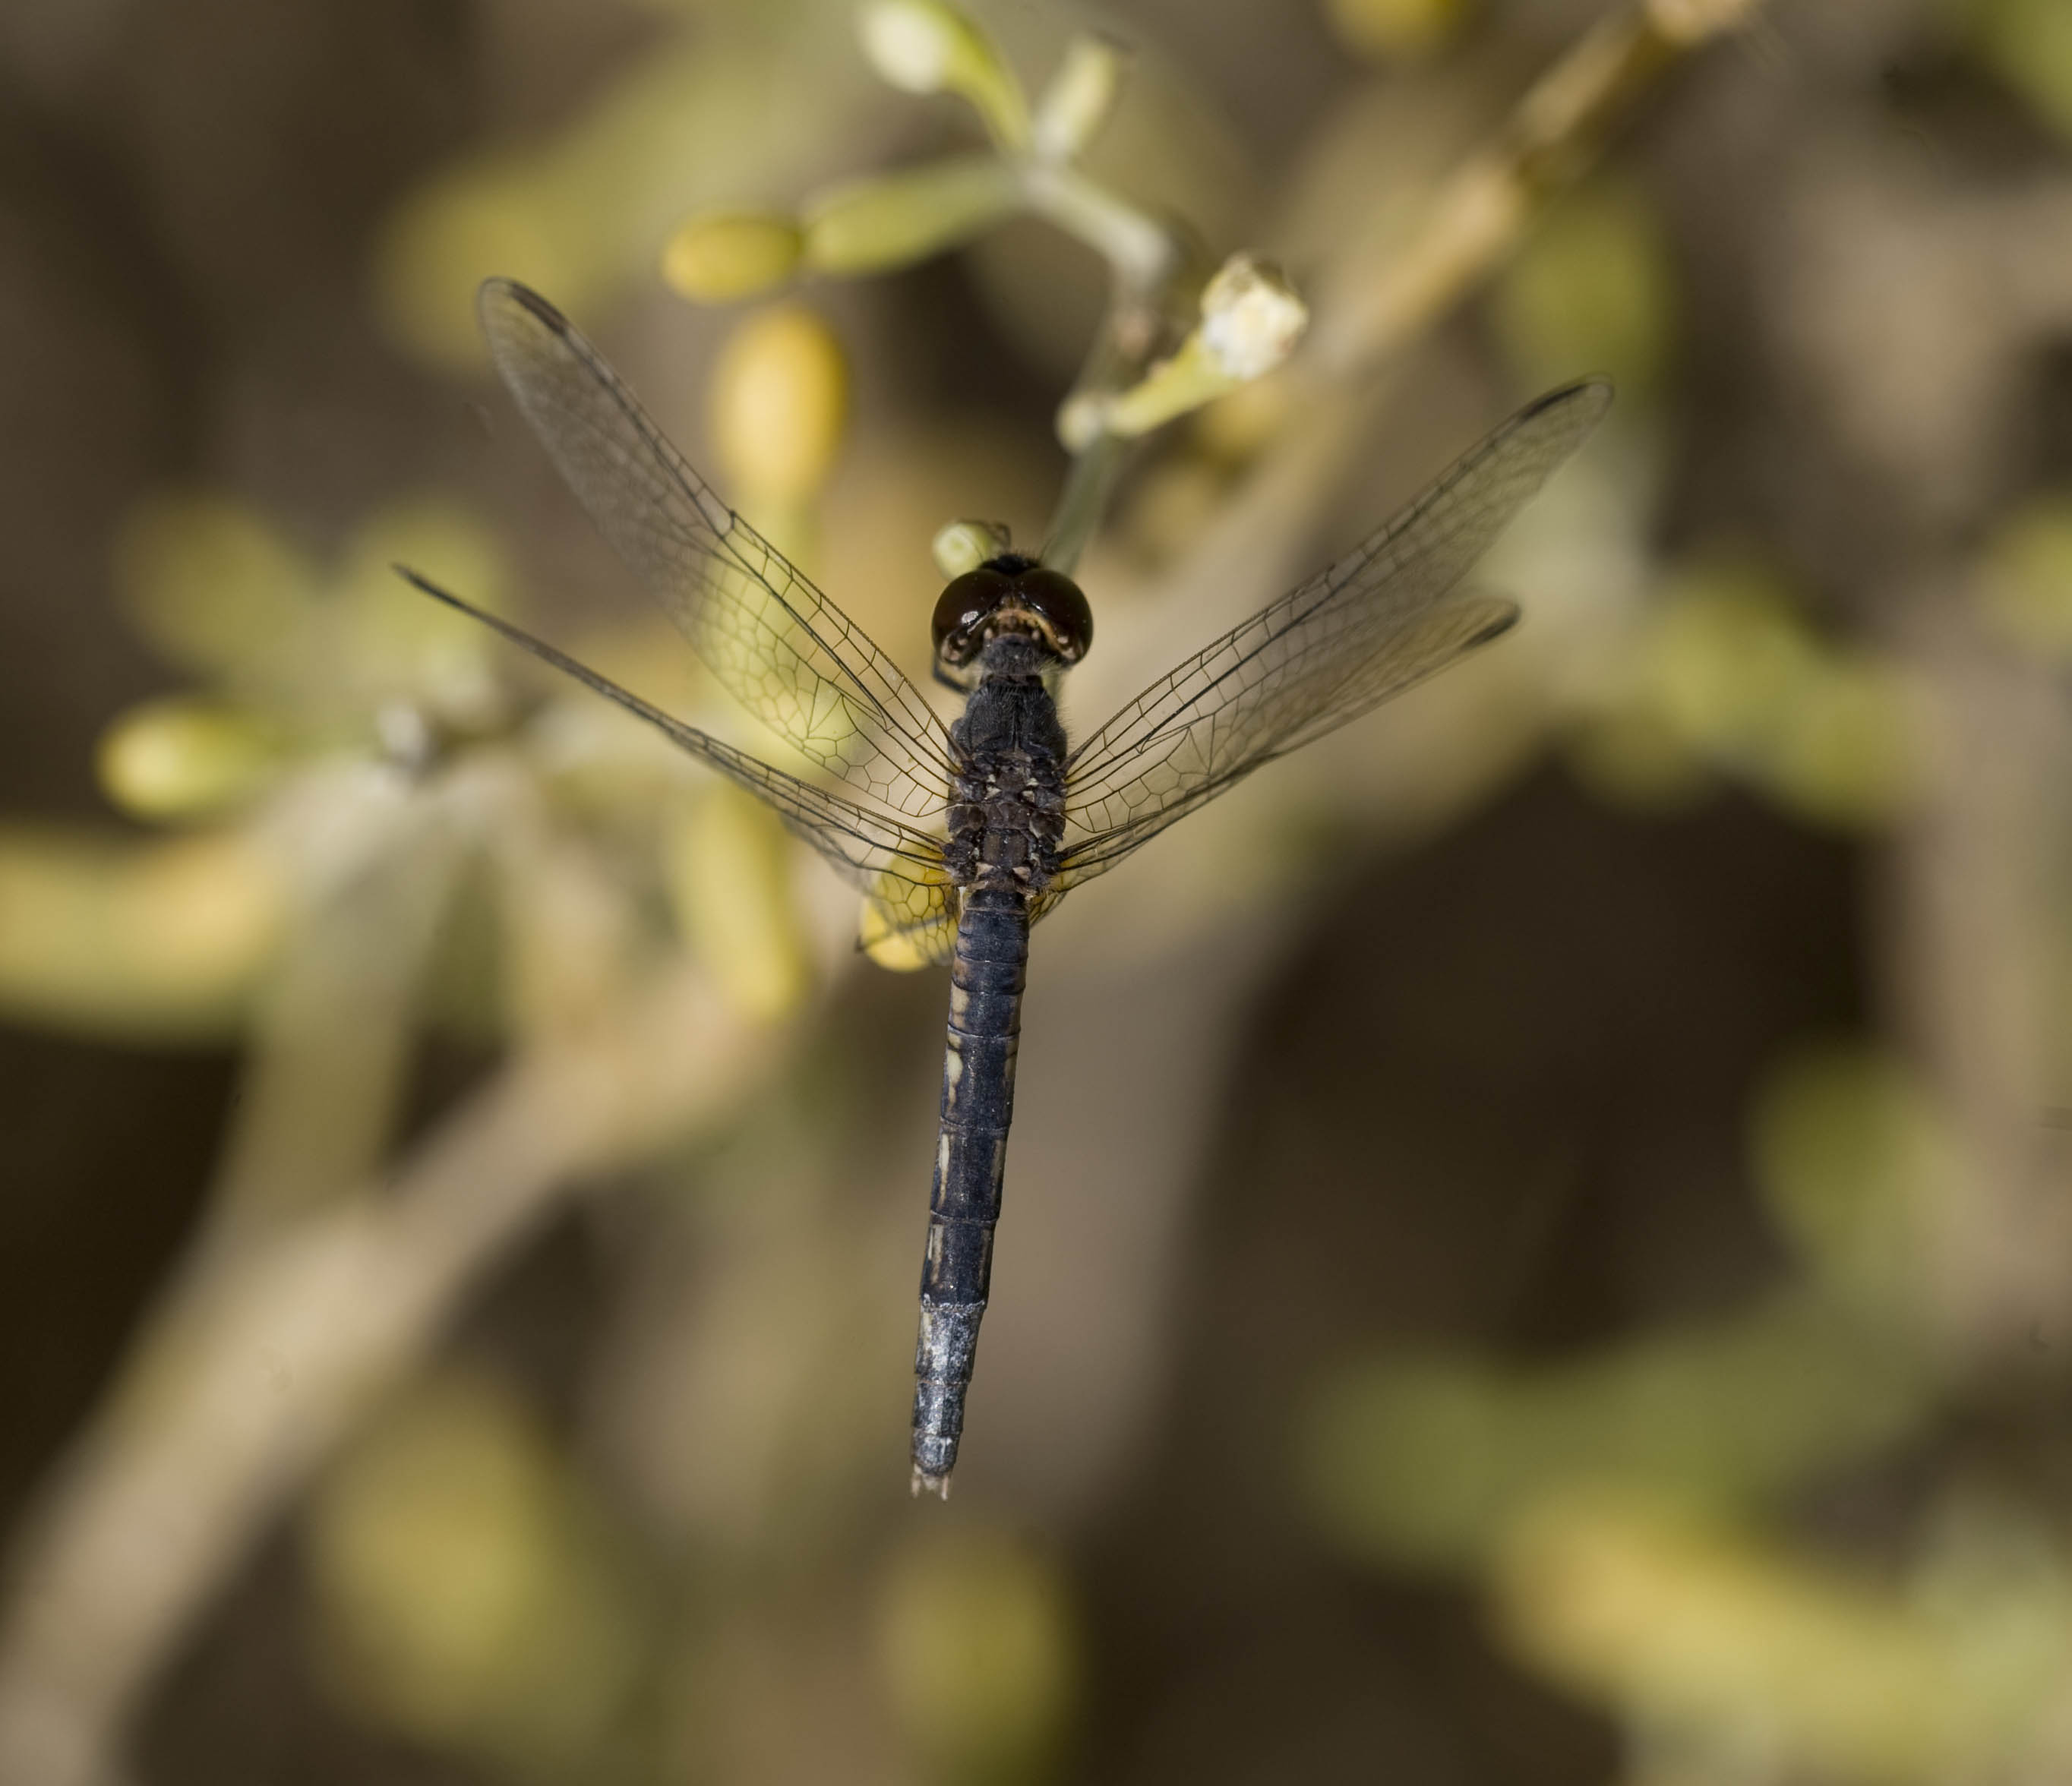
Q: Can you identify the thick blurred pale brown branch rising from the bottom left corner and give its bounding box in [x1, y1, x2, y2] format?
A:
[0, 967, 779, 1786]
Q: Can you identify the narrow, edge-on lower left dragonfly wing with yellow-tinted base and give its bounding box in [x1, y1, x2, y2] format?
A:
[398, 566, 957, 964]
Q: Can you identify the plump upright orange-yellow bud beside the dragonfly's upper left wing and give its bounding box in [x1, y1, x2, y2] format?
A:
[712, 305, 849, 507]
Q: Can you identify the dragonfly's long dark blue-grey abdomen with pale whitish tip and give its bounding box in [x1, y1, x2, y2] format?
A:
[914, 887, 1030, 1494]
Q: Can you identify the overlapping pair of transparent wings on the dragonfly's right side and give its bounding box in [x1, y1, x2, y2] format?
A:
[1055, 381, 1612, 891]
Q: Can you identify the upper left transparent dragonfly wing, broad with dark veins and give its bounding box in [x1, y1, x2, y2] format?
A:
[481, 279, 951, 819]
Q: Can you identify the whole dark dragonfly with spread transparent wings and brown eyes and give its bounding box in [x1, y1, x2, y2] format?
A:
[398, 279, 1612, 1498]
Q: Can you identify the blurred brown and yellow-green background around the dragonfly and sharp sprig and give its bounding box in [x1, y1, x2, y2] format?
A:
[0, 0, 2072, 1786]
